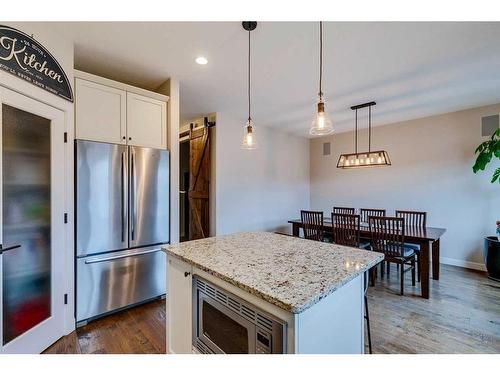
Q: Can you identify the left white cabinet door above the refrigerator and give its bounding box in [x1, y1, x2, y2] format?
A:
[76, 79, 127, 144]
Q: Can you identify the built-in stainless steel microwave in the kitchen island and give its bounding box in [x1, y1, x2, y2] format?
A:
[193, 276, 287, 354]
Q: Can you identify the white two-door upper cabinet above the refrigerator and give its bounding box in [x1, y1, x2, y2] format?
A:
[75, 71, 168, 149]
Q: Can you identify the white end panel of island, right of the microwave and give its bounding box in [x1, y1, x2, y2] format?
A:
[295, 274, 364, 354]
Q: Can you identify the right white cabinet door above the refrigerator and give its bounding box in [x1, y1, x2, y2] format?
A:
[127, 92, 167, 148]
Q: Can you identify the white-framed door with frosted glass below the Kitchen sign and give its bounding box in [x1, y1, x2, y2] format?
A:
[0, 89, 64, 353]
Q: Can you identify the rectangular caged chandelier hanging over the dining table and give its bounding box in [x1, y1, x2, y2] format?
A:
[337, 102, 391, 169]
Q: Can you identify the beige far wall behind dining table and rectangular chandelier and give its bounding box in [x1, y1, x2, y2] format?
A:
[310, 104, 500, 268]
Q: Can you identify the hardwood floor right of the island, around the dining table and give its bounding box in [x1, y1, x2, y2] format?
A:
[368, 265, 500, 354]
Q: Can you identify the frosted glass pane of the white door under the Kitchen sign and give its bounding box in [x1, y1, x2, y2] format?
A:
[2, 104, 51, 345]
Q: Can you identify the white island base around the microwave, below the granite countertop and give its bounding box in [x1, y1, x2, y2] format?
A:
[167, 255, 364, 354]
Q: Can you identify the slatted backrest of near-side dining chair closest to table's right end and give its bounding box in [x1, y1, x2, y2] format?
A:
[368, 216, 405, 257]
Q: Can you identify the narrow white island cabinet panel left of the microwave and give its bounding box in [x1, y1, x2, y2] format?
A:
[167, 256, 193, 354]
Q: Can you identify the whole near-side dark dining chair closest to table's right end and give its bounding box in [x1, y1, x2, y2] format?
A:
[368, 216, 416, 295]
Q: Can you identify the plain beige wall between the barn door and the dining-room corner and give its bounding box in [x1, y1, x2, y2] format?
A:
[216, 112, 309, 235]
